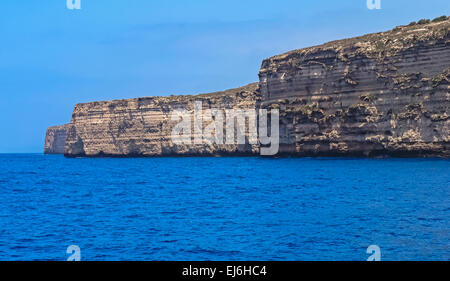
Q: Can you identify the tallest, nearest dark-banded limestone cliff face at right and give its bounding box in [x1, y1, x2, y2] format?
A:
[259, 19, 450, 157]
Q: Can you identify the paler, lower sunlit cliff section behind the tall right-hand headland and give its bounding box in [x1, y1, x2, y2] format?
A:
[65, 83, 259, 157]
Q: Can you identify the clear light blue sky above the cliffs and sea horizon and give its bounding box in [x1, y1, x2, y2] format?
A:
[0, 0, 450, 153]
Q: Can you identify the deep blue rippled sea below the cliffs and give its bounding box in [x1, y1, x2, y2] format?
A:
[0, 154, 450, 261]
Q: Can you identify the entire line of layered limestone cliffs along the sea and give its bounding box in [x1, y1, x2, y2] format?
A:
[46, 17, 450, 157]
